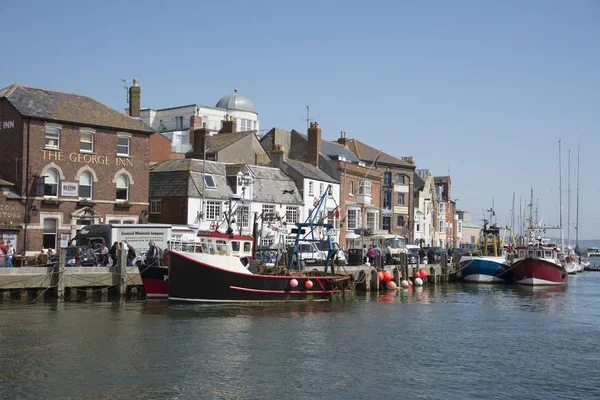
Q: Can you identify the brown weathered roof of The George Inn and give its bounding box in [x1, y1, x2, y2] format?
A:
[0, 84, 154, 134]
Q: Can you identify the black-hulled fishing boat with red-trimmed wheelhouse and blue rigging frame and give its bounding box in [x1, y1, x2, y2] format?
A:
[168, 189, 355, 303]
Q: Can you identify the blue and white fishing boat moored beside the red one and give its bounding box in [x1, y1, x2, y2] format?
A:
[456, 221, 514, 283]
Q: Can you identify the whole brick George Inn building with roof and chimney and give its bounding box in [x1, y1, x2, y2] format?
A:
[0, 80, 154, 252]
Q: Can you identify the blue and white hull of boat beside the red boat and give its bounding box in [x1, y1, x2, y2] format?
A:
[457, 256, 513, 283]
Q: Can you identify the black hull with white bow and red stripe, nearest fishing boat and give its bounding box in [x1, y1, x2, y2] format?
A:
[169, 251, 354, 303]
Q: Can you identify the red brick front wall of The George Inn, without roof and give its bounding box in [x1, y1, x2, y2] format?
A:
[0, 100, 152, 252]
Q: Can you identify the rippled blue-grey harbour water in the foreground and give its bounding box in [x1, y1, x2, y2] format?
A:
[0, 266, 600, 399]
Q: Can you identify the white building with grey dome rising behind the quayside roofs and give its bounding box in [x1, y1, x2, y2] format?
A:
[140, 89, 260, 153]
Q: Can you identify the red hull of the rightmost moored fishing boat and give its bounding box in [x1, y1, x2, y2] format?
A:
[513, 258, 569, 286]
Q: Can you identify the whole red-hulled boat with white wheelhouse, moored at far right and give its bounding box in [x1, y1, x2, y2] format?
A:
[512, 243, 569, 286]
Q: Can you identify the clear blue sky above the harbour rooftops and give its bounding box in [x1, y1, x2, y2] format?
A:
[0, 0, 600, 239]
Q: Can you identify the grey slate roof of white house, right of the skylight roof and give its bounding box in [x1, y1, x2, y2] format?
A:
[248, 165, 303, 205]
